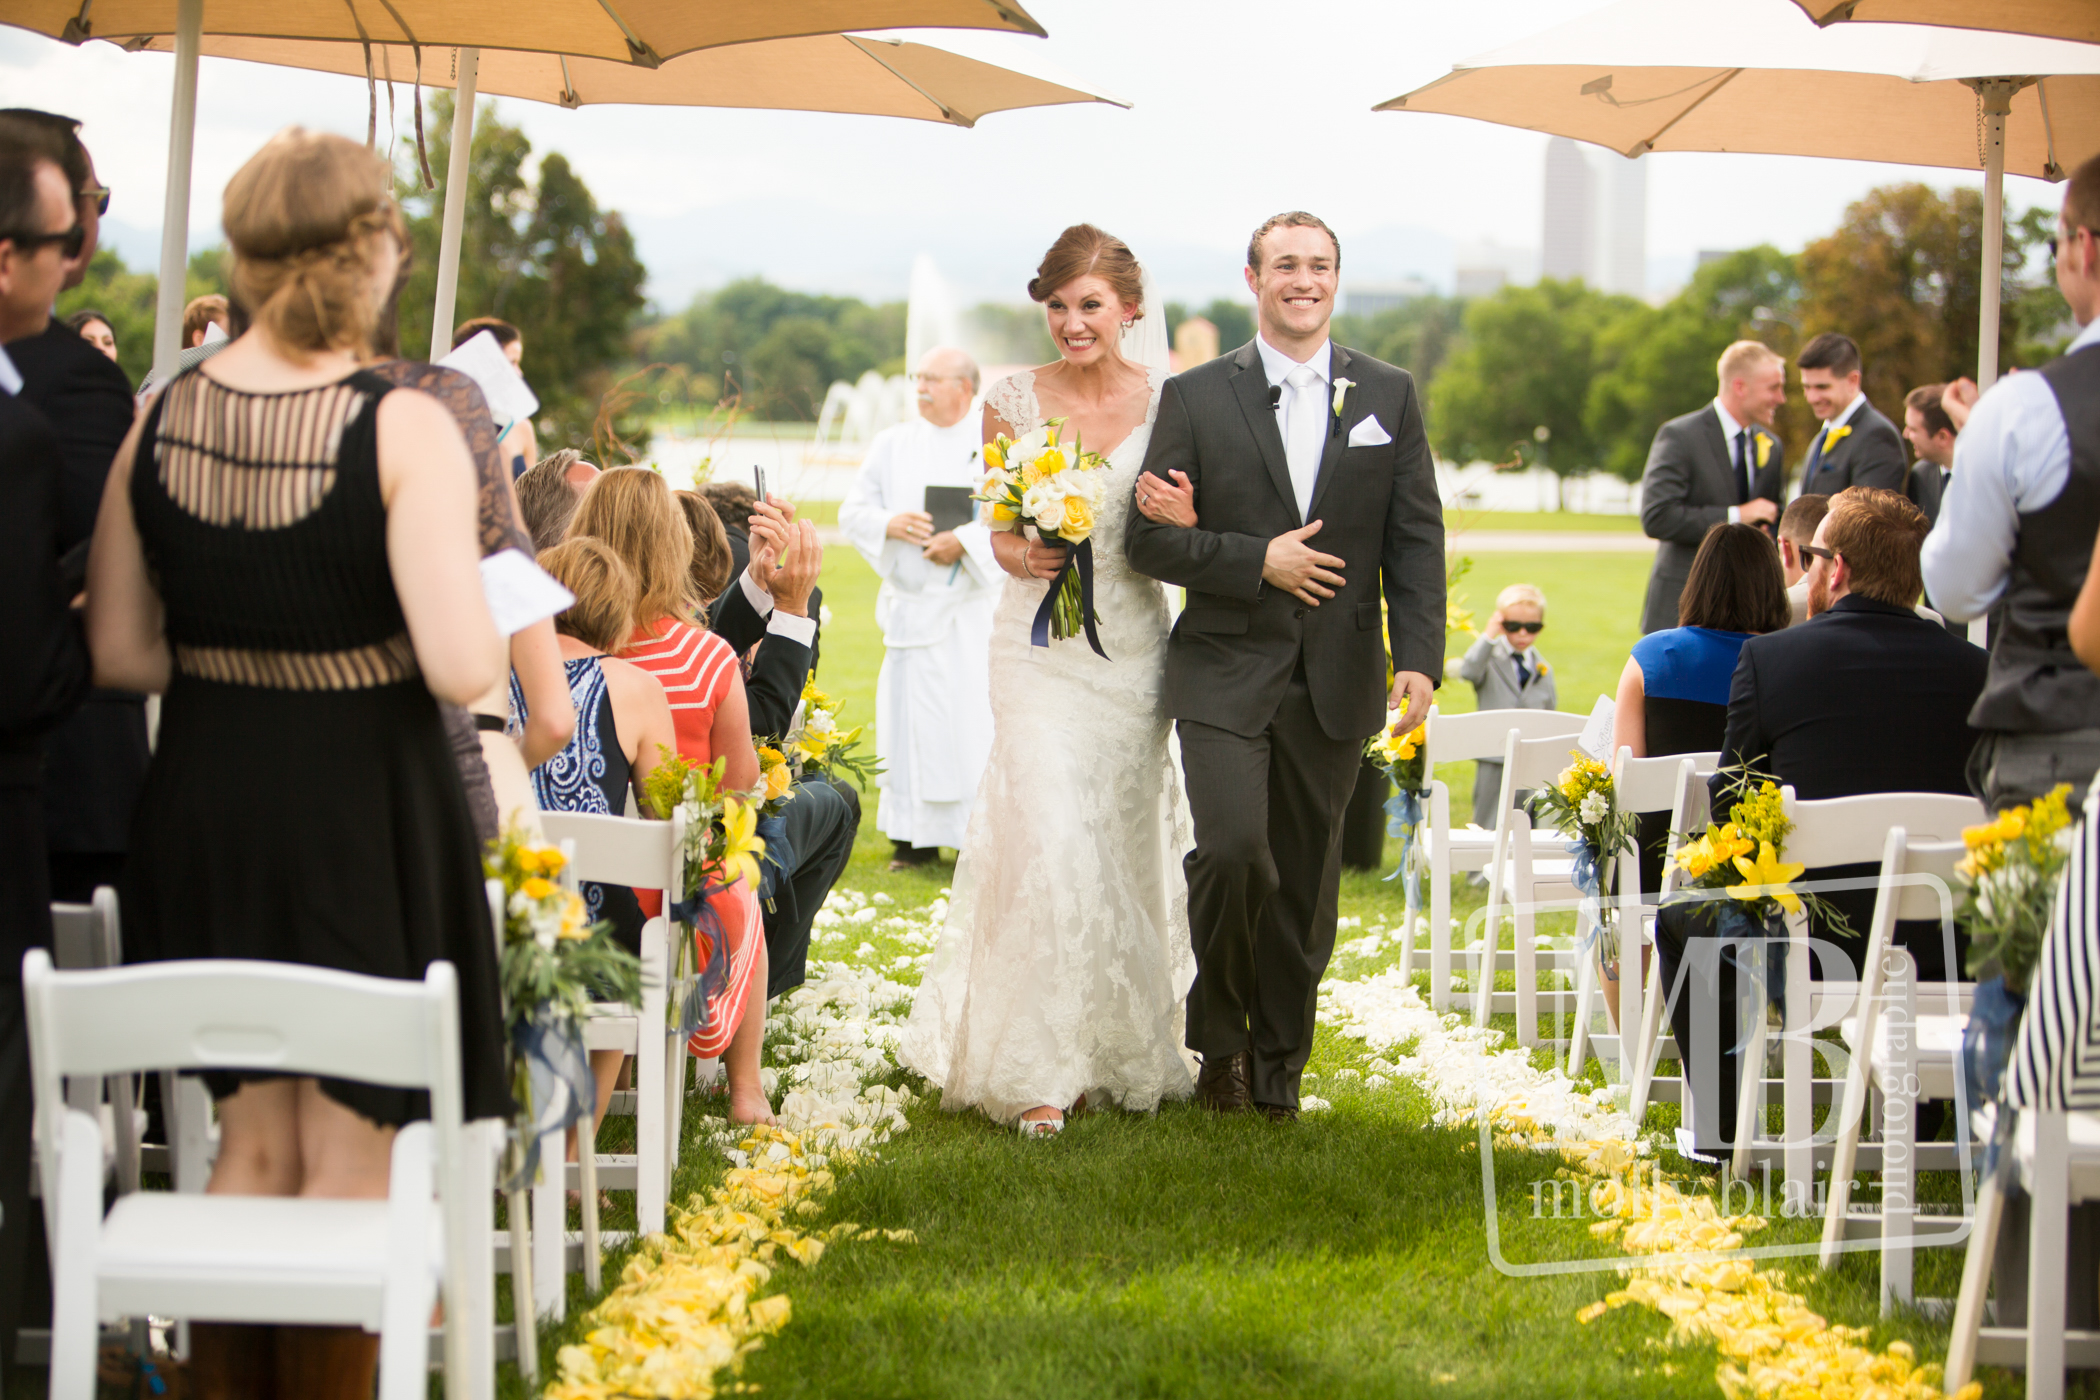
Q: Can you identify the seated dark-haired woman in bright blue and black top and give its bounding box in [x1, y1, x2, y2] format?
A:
[1613, 525, 1793, 896]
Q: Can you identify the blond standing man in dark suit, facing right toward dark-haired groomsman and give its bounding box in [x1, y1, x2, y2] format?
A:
[1640, 340, 1787, 632]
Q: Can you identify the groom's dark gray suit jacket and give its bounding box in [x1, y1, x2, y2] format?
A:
[1124, 340, 1445, 739]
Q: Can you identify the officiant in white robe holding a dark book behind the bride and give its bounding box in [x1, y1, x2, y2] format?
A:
[838, 346, 1004, 871]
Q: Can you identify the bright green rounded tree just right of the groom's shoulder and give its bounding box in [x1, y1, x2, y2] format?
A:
[1428, 279, 1640, 474]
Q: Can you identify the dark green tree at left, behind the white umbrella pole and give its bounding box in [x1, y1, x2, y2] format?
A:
[399, 92, 647, 449]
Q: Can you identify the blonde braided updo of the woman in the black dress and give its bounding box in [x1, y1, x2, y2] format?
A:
[221, 126, 407, 355]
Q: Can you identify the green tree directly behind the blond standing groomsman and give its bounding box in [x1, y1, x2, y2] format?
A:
[1583, 246, 1806, 481]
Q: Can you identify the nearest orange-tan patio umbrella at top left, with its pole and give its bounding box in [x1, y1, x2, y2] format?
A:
[0, 0, 1044, 376]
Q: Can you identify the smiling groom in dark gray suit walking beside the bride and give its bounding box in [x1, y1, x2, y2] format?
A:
[1126, 212, 1445, 1121]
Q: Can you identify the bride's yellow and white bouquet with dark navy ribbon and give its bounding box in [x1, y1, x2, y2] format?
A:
[972, 418, 1109, 659]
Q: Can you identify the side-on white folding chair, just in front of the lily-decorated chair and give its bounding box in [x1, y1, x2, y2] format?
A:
[1819, 831, 1982, 1314]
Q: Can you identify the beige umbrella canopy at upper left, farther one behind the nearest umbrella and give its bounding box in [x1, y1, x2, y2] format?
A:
[137, 34, 1130, 126]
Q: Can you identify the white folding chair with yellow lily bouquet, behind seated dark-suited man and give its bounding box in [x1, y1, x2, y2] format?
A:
[1733, 787, 1985, 1211]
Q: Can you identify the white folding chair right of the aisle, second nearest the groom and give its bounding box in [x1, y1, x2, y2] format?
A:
[1472, 728, 1581, 1045]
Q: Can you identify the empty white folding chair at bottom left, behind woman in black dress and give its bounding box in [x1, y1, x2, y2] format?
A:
[23, 949, 470, 1400]
